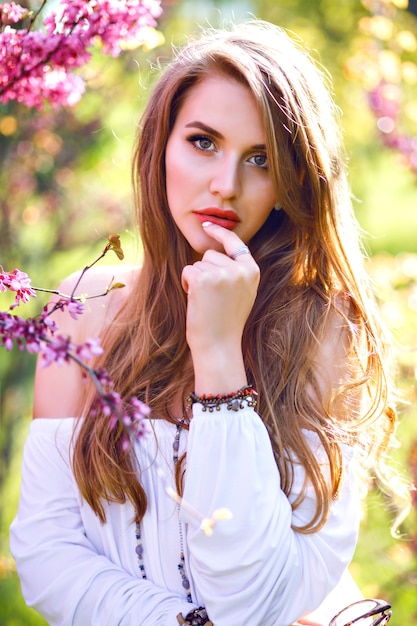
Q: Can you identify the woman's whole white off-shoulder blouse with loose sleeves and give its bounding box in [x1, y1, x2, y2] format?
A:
[10, 405, 359, 626]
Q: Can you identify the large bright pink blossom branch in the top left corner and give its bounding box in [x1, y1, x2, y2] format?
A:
[0, 0, 162, 109]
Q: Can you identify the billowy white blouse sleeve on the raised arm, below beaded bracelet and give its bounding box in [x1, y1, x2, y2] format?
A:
[182, 405, 359, 626]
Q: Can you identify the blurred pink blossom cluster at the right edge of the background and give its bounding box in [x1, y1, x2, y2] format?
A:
[369, 81, 417, 172]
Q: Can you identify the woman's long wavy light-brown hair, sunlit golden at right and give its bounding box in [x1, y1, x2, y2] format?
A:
[73, 21, 404, 532]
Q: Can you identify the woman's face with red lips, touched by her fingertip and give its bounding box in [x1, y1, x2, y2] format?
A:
[165, 74, 277, 257]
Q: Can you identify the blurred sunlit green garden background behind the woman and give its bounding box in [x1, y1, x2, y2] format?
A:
[0, 0, 417, 626]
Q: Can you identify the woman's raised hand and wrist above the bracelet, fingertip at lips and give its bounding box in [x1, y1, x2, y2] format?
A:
[182, 222, 259, 393]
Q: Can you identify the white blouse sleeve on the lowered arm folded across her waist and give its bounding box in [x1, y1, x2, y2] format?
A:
[10, 419, 190, 626]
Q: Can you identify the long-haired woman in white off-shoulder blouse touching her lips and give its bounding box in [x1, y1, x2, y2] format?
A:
[11, 22, 395, 626]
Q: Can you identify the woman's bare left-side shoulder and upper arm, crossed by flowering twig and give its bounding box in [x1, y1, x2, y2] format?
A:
[33, 266, 140, 418]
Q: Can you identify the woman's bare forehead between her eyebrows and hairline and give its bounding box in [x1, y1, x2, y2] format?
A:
[176, 73, 264, 142]
